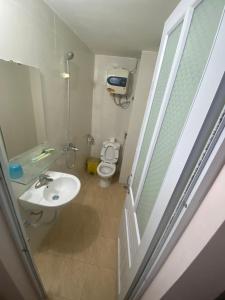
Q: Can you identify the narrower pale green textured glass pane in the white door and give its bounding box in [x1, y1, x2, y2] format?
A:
[132, 22, 183, 198]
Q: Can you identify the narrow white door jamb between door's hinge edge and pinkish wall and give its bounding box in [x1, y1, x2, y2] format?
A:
[131, 109, 225, 300]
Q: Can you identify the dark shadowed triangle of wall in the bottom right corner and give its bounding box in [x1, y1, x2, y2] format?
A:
[162, 222, 225, 300]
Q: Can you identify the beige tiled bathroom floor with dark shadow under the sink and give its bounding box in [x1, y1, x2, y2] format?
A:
[35, 174, 125, 300]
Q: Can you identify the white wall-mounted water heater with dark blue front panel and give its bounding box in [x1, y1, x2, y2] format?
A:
[106, 68, 129, 95]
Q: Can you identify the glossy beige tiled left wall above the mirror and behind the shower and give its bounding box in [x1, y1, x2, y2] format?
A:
[0, 0, 94, 171]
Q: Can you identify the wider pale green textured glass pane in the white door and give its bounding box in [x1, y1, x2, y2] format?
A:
[137, 0, 225, 236]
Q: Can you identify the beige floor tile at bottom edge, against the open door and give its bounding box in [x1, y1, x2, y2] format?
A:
[81, 265, 117, 300]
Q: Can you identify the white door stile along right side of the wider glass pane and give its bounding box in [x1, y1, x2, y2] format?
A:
[136, 0, 225, 270]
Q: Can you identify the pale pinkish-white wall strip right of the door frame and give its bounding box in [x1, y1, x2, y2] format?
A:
[142, 166, 225, 300]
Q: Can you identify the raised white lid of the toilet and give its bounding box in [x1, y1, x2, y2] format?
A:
[101, 142, 120, 164]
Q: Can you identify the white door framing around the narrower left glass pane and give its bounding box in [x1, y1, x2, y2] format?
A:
[125, 0, 196, 268]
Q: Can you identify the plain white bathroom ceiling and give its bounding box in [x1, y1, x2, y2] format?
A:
[45, 0, 179, 56]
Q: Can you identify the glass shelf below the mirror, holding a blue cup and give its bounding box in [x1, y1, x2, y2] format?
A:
[9, 144, 63, 185]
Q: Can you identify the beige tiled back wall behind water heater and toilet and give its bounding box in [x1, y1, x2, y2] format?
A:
[91, 55, 137, 161]
